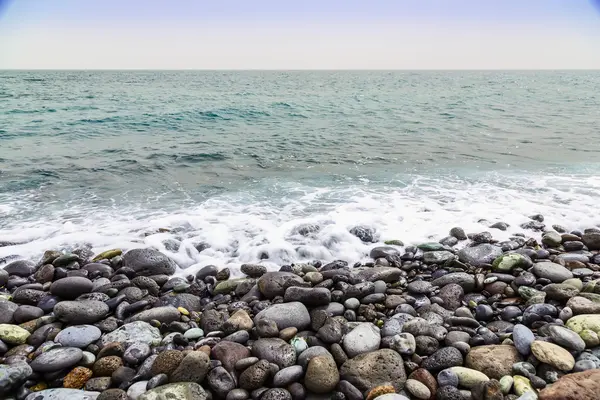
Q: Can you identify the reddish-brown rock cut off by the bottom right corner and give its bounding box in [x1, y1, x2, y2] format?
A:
[539, 369, 600, 400]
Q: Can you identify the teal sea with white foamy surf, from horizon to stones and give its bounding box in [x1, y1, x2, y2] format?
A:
[0, 71, 600, 272]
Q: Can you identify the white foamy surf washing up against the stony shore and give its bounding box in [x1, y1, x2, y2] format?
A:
[0, 175, 600, 275]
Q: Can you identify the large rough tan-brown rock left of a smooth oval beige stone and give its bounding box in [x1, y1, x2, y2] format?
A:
[465, 345, 522, 379]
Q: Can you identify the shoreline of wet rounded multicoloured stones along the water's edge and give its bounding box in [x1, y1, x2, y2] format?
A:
[0, 215, 600, 400]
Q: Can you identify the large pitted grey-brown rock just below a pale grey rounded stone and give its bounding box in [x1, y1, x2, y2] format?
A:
[340, 349, 406, 391]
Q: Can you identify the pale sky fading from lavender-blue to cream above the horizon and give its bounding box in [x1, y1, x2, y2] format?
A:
[0, 0, 600, 69]
